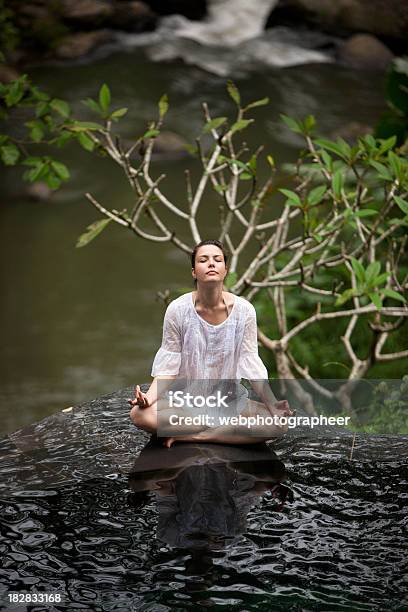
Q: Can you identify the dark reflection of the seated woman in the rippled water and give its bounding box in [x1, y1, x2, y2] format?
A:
[129, 441, 289, 549]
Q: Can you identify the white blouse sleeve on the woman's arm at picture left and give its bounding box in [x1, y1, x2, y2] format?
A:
[151, 303, 181, 376]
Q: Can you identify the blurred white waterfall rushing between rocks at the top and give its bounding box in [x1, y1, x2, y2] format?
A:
[113, 0, 332, 77]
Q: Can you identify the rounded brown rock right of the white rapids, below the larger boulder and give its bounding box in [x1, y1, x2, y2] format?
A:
[338, 34, 394, 70]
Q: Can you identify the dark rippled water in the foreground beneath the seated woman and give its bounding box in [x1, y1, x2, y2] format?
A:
[0, 390, 408, 612]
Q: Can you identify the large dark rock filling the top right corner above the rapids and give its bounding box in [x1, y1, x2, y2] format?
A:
[270, 0, 408, 42]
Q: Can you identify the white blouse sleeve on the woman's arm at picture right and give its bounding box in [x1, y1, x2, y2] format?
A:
[237, 304, 268, 380]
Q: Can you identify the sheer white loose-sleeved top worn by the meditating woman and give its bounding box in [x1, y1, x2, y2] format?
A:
[152, 292, 268, 380]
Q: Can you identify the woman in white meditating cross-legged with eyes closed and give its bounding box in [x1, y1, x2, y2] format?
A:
[129, 240, 292, 448]
